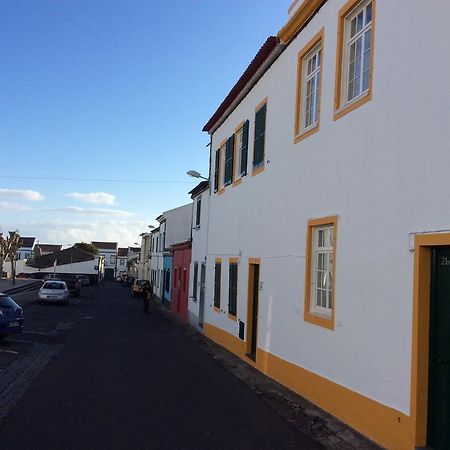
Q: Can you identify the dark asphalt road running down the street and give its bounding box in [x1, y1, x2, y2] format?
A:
[0, 284, 321, 450]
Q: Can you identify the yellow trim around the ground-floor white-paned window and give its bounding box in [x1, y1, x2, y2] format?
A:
[303, 216, 337, 330]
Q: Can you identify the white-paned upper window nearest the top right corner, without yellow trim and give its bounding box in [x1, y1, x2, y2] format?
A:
[341, 0, 372, 106]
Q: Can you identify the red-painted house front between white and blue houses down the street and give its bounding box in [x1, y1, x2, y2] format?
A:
[170, 240, 191, 322]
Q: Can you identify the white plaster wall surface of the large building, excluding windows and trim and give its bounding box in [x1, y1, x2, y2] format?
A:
[206, 0, 450, 414]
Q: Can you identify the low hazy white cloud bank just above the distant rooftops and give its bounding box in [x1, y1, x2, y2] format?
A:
[5, 219, 148, 247]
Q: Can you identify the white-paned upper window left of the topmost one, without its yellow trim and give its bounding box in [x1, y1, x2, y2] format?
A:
[300, 43, 322, 133]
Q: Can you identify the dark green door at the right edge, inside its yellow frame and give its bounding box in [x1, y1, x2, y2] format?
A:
[427, 248, 450, 450]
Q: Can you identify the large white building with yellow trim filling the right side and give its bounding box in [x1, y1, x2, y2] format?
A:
[204, 0, 450, 449]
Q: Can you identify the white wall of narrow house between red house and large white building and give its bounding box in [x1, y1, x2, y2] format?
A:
[188, 189, 211, 331]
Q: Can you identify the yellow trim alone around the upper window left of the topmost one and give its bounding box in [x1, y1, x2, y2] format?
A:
[294, 28, 325, 144]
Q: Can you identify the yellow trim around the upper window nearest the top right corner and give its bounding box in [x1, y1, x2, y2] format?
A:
[333, 0, 376, 120]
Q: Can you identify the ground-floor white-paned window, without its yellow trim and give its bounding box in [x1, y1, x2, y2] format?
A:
[310, 224, 334, 316]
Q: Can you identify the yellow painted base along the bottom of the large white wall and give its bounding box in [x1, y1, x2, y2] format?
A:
[204, 324, 415, 450]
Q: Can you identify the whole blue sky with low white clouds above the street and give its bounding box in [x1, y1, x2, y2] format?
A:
[0, 0, 291, 246]
